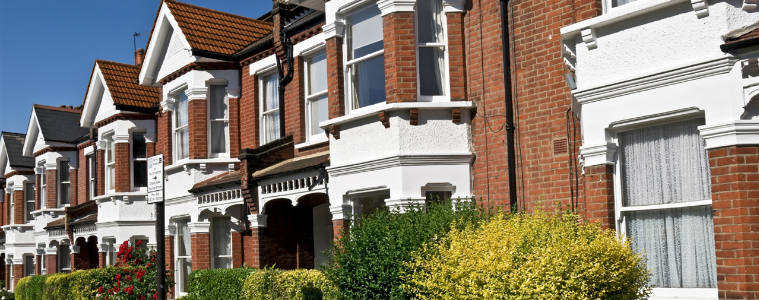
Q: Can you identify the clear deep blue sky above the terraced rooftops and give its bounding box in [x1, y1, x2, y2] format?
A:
[0, 0, 272, 132]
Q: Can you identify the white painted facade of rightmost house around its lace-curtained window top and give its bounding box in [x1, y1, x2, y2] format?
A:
[561, 0, 759, 299]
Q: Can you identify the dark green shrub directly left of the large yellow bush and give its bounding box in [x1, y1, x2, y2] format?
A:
[325, 201, 484, 299]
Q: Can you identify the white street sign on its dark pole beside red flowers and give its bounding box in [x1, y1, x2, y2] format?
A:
[148, 154, 166, 300]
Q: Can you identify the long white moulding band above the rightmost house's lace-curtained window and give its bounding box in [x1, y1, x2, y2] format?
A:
[572, 57, 736, 104]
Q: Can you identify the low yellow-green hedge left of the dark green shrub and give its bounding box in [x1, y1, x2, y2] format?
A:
[243, 269, 337, 300]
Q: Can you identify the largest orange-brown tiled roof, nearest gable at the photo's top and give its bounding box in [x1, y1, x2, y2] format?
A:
[164, 0, 273, 55]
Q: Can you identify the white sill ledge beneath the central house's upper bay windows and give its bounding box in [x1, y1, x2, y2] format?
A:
[319, 101, 475, 128]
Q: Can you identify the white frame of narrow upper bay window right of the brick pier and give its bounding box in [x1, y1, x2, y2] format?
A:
[414, 1, 451, 102]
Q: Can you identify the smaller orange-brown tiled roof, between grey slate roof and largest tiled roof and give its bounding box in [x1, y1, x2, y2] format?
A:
[95, 60, 161, 108]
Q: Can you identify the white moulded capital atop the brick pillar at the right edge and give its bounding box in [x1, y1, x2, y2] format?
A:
[698, 120, 759, 149]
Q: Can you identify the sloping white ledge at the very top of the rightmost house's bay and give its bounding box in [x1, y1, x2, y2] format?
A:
[560, 0, 686, 39]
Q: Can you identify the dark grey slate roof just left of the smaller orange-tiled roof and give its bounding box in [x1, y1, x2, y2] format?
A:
[34, 104, 90, 143]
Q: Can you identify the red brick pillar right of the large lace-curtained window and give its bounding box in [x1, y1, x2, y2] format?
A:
[709, 146, 759, 299]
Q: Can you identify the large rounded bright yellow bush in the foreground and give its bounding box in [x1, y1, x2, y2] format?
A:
[403, 213, 650, 299]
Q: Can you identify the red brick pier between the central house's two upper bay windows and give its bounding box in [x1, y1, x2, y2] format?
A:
[382, 12, 416, 103]
